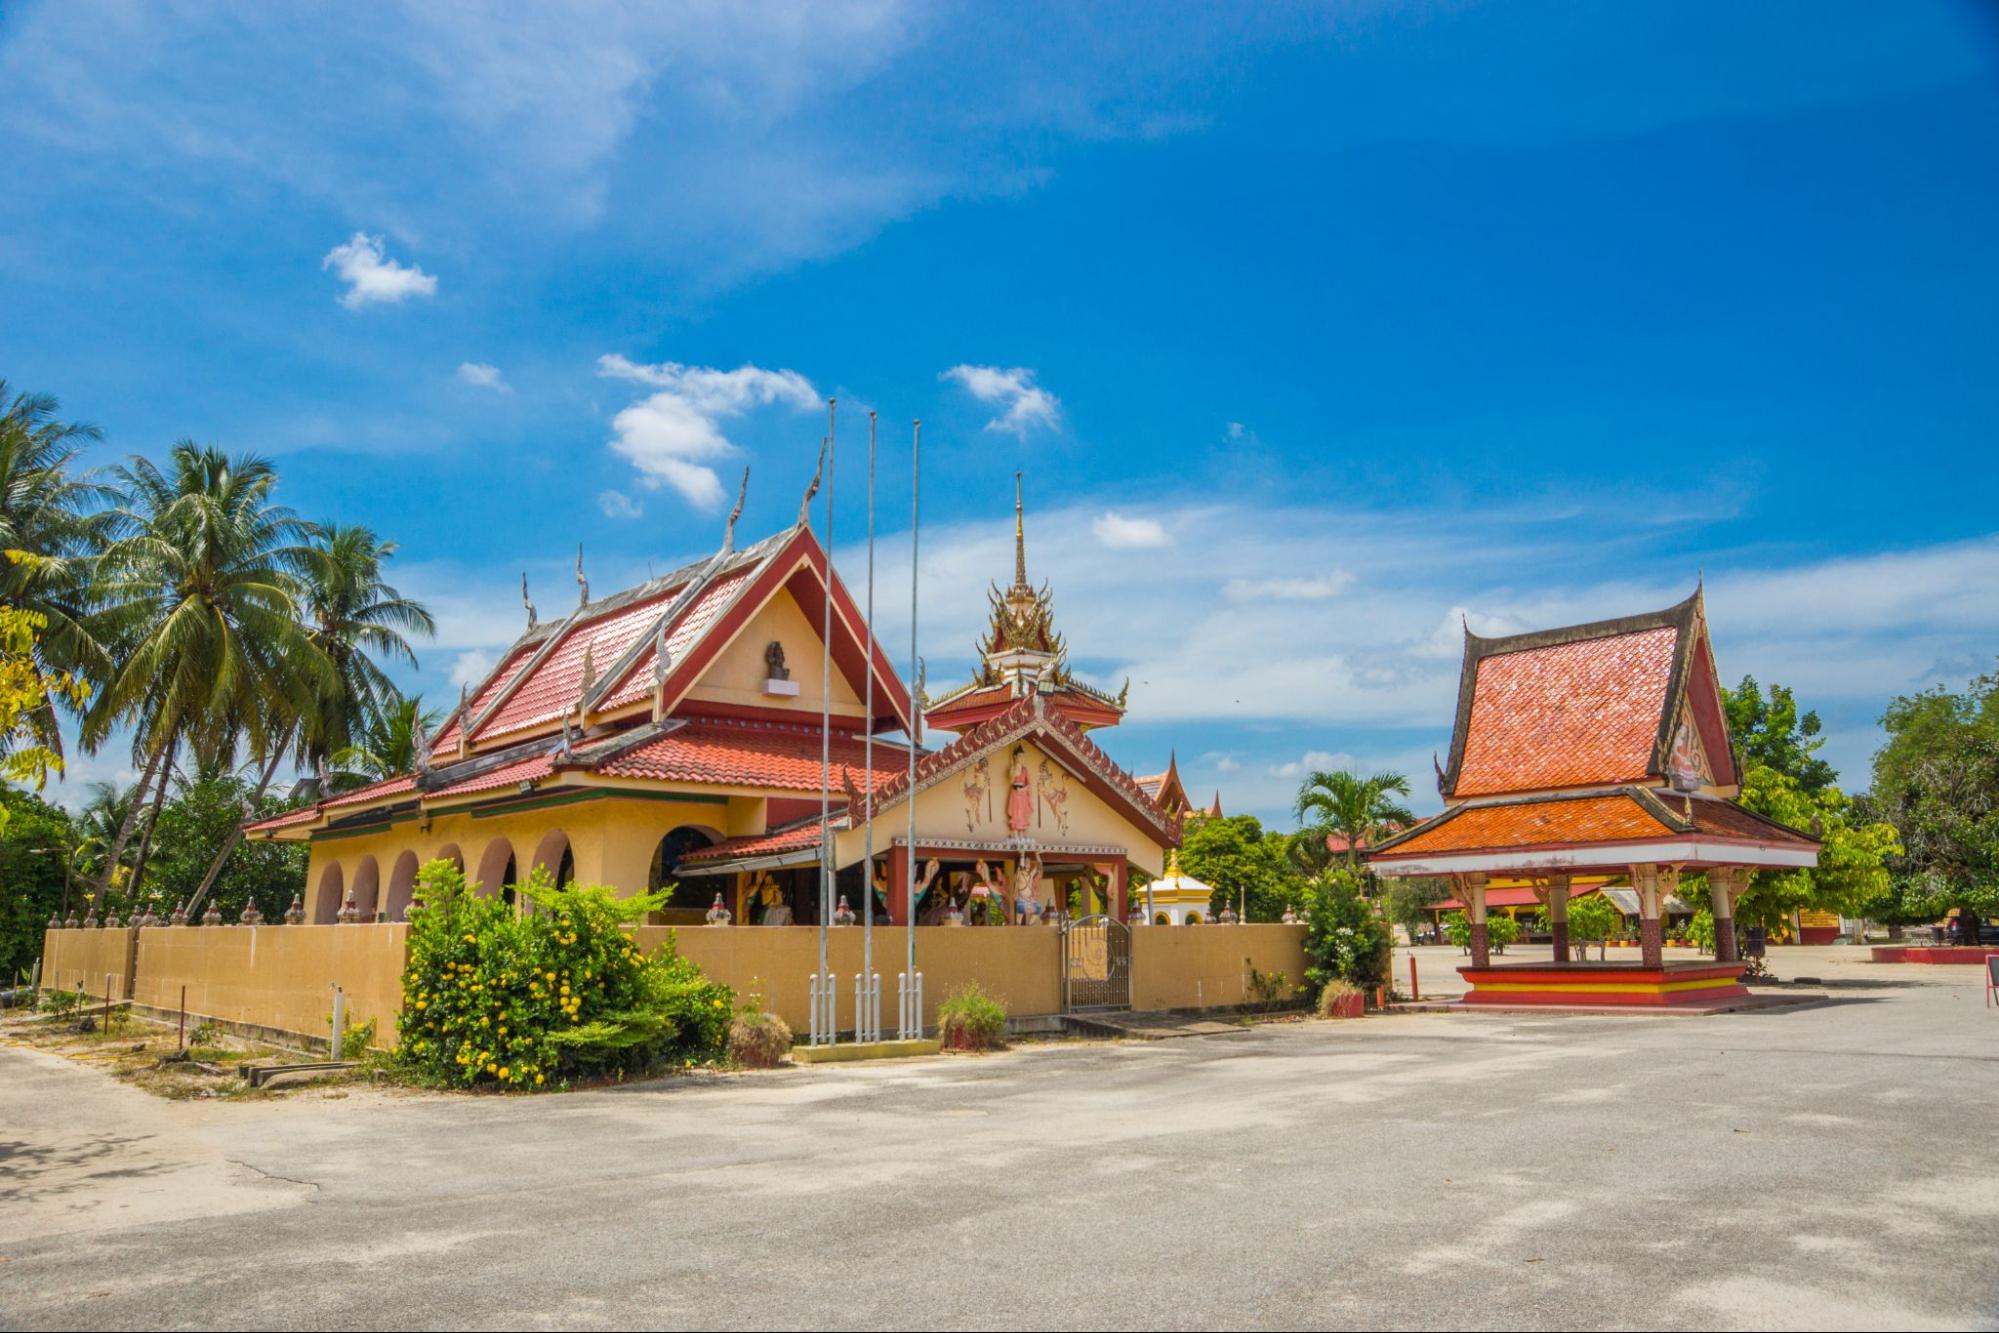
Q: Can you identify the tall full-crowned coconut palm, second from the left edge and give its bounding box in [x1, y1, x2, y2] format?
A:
[84, 440, 332, 895]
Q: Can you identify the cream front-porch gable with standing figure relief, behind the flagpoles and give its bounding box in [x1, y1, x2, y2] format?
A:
[840, 741, 1165, 875]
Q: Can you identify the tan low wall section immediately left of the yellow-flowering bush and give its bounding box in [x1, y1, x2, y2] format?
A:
[132, 921, 410, 1047]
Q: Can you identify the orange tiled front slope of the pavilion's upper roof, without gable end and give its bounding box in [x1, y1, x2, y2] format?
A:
[1451, 626, 1679, 797]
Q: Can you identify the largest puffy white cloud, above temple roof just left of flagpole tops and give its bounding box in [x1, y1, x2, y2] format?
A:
[598, 354, 822, 510]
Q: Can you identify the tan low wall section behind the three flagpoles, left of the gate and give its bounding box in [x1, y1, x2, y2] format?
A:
[638, 925, 1061, 1033]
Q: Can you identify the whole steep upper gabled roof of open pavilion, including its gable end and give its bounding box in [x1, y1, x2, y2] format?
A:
[1439, 592, 1737, 801]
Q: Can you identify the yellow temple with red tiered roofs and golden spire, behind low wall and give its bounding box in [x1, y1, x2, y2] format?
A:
[248, 485, 1179, 925]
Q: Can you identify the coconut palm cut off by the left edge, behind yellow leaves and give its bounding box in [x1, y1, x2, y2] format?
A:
[0, 380, 116, 755]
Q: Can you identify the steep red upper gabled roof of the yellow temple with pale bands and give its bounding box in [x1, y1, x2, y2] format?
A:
[432, 524, 910, 757]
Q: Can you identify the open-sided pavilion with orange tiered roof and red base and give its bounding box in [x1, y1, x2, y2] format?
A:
[1367, 590, 1819, 1005]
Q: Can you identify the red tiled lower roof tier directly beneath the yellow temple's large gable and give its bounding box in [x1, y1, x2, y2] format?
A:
[596, 717, 910, 791]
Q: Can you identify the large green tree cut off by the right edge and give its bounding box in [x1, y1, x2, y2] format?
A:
[1869, 673, 1999, 939]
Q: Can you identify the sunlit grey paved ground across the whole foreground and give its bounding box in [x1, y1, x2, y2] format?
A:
[0, 953, 1999, 1329]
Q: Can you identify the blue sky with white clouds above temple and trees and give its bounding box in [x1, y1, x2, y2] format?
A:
[0, 0, 1999, 819]
